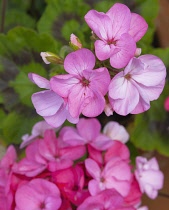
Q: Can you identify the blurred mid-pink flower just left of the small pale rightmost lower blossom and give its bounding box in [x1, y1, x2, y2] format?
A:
[85, 157, 131, 196]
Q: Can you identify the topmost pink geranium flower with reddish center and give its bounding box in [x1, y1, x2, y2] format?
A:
[85, 3, 148, 68]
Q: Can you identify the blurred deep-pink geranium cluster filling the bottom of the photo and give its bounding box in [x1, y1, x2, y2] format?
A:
[0, 118, 163, 210]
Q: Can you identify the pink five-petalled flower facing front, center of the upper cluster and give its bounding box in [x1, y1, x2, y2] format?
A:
[50, 48, 110, 118]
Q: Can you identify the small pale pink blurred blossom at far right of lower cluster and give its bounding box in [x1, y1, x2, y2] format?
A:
[135, 157, 164, 199]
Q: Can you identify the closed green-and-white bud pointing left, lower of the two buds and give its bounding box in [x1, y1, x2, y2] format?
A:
[40, 52, 63, 64]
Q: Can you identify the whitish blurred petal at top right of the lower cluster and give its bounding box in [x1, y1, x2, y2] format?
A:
[103, 121, 129, 143]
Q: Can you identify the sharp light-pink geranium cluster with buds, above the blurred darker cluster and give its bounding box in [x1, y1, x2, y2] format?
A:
[29, 3, 166, 127]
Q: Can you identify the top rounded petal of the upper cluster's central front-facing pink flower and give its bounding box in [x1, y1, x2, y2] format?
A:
[64, 48, 95, 75]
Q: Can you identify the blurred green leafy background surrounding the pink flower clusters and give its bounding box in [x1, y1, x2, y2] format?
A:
[0, 0, 169, 210]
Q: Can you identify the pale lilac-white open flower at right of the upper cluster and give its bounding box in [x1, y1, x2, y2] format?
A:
[109, 55, 166, 115]
